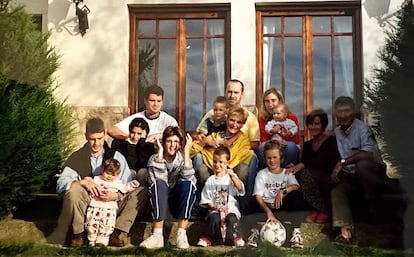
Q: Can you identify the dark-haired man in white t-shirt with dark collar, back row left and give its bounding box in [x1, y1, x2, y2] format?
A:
[108, 86, 178, 142]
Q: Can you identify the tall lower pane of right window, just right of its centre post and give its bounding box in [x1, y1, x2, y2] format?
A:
[313, 37, 332, 126]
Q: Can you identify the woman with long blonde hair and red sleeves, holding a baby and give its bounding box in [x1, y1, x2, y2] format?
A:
[256, 88, 300, 170]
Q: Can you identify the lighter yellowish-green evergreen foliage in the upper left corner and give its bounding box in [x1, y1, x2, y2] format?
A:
[0, 0, 58, 86]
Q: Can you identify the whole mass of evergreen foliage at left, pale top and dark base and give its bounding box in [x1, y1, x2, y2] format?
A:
[0, 0, 75, 217]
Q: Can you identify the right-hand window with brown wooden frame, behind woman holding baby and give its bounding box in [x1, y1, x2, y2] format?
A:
[256, 1, 362, 134]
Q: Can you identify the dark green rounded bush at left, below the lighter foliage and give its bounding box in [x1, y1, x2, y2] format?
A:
[0, 76, 73, 216]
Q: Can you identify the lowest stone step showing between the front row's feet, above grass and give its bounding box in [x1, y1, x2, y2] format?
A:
[0, 213, 403, 249]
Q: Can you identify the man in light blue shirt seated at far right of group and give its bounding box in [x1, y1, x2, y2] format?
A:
[331, 96, 389, 242]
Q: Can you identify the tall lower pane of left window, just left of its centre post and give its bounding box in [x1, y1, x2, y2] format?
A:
[158, 39, 176, 116]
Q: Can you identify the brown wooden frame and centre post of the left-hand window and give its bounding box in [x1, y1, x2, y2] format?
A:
[128, 4, 231, 127]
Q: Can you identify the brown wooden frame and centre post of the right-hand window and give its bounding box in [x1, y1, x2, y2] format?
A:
[256, 1, 363, 134]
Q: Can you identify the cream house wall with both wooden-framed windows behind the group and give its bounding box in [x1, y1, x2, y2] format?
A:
[14, 0, 403, 144]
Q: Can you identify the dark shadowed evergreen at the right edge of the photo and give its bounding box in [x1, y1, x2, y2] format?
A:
[365, 0, 414, 179]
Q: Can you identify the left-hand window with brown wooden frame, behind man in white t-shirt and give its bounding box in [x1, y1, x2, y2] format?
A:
[129, 4, 230, 130]
